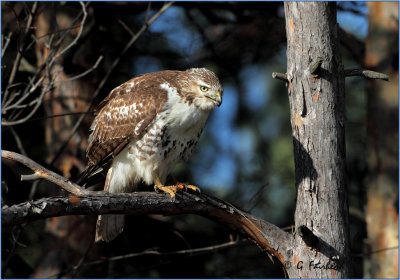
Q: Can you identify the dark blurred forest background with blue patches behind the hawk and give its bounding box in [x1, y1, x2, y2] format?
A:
[1, 2, 398, 278]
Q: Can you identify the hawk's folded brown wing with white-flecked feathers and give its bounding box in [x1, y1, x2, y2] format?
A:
[81, 71, 178, 183]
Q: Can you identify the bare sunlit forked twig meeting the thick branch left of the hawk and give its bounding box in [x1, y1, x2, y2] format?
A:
[1, 150, 88, 195]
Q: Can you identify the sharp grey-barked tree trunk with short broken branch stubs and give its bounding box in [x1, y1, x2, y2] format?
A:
[285, 2, 350, 278]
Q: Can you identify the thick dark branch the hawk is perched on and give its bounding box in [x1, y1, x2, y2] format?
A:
[1, 192, 292, 264]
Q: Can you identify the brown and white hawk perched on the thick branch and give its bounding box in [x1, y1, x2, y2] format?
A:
[82, 68, 223, 242]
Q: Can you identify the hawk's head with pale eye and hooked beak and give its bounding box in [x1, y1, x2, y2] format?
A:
[184, 68, 224, 111]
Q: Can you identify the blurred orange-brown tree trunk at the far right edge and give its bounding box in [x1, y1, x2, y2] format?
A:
[364, 2, 399, 278]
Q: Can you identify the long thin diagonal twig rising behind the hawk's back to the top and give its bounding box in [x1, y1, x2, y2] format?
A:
[50, 2, 174, 166]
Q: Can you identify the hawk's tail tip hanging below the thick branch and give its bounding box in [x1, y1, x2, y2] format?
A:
[95, 215, 125, 242]
